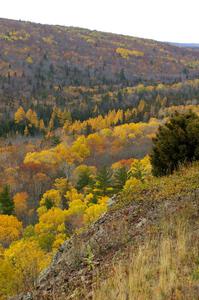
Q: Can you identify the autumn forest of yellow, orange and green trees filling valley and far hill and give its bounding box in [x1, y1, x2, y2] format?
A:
[0, 19, 199, 300]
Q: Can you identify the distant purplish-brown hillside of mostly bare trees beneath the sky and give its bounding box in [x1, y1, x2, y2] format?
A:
[0, 19, 199, 122]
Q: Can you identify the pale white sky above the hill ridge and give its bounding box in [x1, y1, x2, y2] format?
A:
[0, 0, 199, 43]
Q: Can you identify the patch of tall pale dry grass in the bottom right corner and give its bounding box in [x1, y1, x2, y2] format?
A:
[93, 212, 199, 300]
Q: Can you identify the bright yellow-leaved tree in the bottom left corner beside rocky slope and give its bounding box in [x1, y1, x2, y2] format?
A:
[0, 239, 51, 299]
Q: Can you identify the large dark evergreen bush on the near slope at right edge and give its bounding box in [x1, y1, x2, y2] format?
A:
[151, 112, 199, 176]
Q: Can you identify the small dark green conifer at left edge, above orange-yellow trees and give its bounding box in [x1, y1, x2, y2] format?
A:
[0, 185, 14, 215]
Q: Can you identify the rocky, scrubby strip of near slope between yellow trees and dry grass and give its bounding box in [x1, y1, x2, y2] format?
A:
[17, 164, 199, 300]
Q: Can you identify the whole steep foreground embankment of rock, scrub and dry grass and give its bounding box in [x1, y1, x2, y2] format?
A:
[15, 163, 199, 300]
